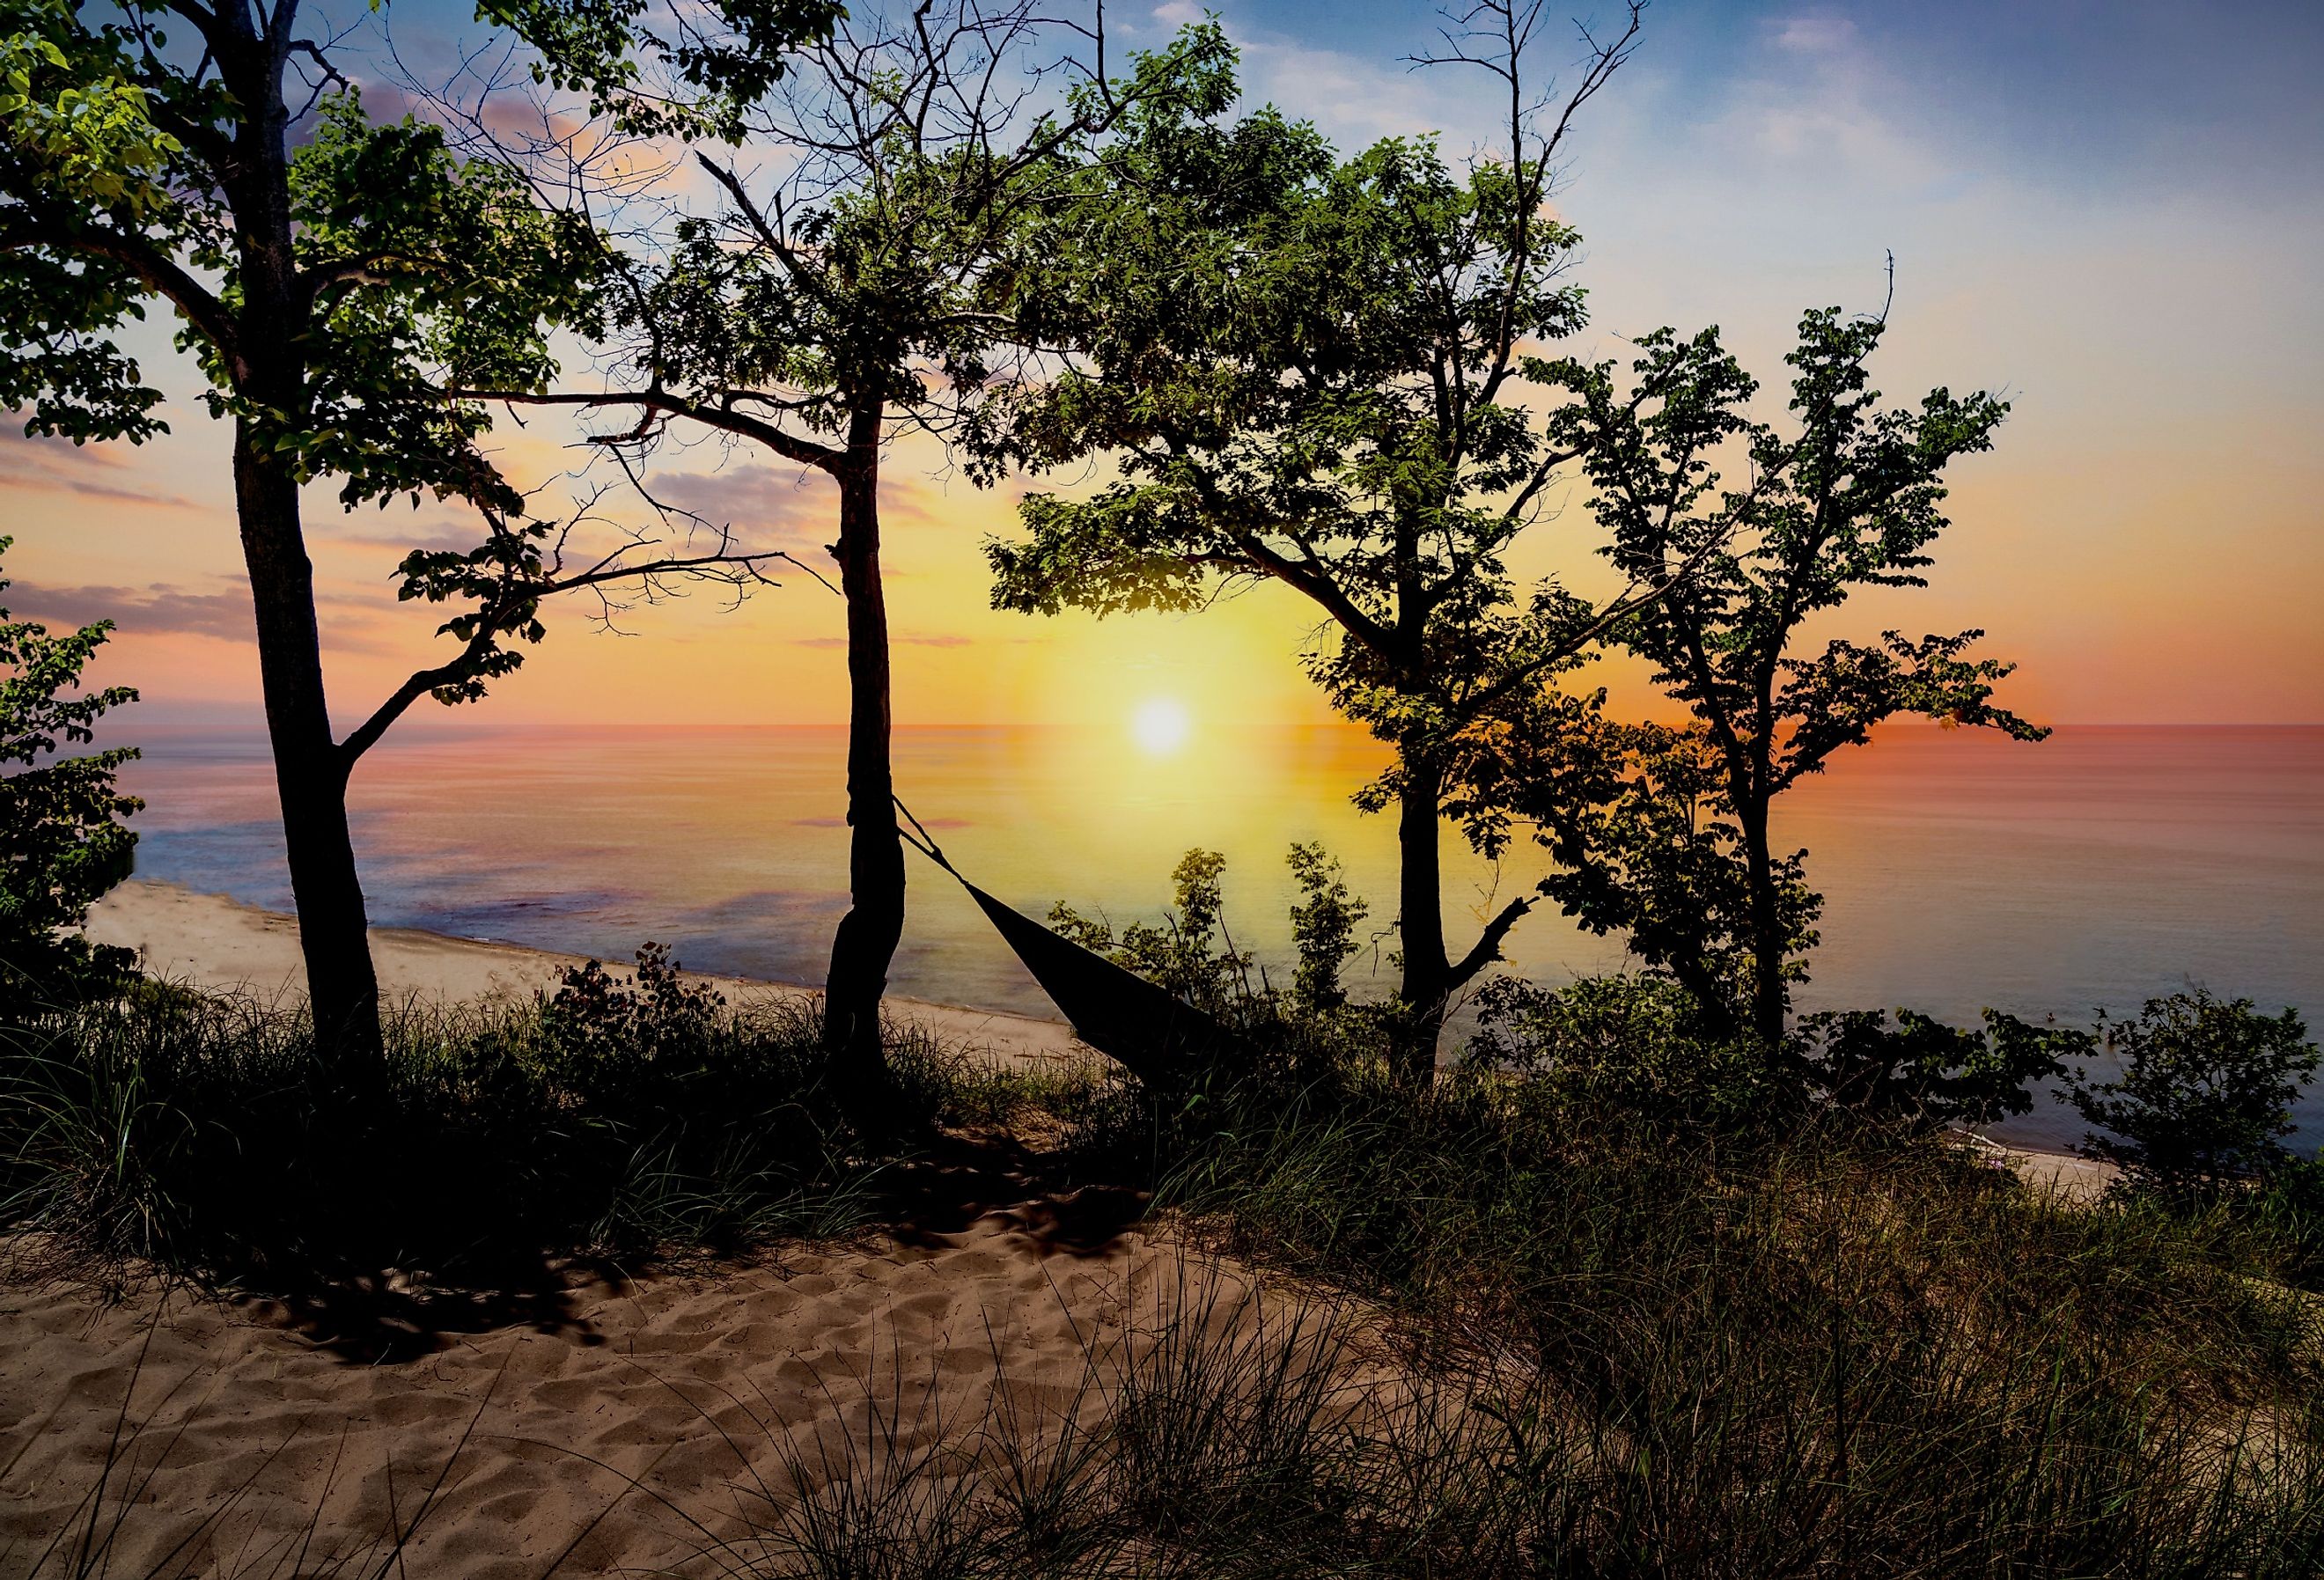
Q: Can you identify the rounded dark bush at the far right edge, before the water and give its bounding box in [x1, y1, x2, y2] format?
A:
[2066, 988, 2320, 1192]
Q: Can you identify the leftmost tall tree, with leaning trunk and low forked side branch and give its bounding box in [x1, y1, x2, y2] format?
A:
[0, 0, 827, 1057]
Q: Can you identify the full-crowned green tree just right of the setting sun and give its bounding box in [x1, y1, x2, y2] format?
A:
[990, 0, 1657, 1074]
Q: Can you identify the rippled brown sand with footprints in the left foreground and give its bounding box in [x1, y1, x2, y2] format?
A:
[0, 1213, 1297, 1580]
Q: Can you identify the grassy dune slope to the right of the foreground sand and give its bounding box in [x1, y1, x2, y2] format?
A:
[1032, 1036, 2324, 1577]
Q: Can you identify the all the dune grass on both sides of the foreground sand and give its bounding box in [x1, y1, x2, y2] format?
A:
[0, 992, 2324, 1580]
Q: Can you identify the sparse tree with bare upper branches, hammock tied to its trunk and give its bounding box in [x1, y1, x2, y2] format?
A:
[472, 0, 1230, 1090]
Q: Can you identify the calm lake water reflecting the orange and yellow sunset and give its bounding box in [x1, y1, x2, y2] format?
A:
[123, 725, 2324, 1145]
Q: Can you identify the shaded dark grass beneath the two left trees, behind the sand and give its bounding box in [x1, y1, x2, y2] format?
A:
[0, 985, 944, 1285]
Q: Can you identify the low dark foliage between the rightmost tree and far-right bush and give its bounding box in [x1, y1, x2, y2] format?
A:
[1791, 1009, 2089, 1129]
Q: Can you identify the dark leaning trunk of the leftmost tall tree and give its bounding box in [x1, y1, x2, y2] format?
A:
[235, 418, 381, 1064]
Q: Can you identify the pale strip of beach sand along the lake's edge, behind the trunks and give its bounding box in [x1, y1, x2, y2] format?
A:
[88, 878, 1090, 1060]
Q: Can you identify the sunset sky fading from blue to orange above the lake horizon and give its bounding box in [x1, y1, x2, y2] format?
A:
[0, 0, 2324, 730]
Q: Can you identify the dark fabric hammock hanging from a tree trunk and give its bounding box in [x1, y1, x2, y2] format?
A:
[894, 799, 1243, 1087]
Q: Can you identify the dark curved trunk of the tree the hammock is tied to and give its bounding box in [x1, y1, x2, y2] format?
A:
[823, 434, 904, 1094]
